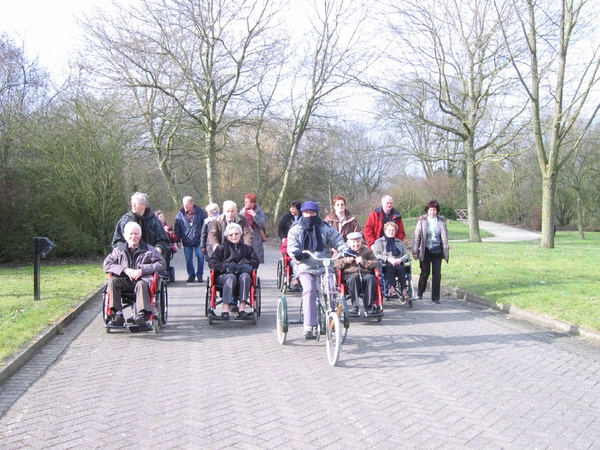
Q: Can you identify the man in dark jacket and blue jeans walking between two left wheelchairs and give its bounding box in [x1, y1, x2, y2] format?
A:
[175, 196, 206, 283]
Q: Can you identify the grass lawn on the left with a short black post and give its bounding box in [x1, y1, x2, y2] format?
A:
[0, 262, 106, 362]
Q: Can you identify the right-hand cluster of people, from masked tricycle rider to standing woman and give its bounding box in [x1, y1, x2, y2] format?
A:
[278, 195, 449, 339]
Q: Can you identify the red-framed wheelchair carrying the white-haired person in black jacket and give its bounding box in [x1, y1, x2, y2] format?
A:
[204, 269, 261, 325]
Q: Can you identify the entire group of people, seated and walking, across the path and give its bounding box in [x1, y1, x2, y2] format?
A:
[104, 192, 448, 330]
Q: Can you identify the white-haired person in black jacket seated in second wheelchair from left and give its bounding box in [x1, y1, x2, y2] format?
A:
[208, 223, 259, 320]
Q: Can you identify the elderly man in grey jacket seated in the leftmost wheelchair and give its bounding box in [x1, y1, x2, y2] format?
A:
[103, 222, 166, 327]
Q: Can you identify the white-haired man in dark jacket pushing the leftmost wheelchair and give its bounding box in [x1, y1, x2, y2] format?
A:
[112, 192, 171, 255]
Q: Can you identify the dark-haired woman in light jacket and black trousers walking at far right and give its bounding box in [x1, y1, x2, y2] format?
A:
[412, 200, 449, 303]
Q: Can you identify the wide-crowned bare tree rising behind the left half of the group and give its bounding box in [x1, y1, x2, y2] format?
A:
[86, 0, 274, 201]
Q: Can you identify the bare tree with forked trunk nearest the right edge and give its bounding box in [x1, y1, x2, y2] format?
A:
[503, 0, 600, 248]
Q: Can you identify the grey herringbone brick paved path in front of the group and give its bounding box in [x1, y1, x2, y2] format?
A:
[0, 244, 600, 449]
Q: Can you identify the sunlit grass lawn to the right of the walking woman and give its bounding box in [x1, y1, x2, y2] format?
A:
[442, 232, 600, 331]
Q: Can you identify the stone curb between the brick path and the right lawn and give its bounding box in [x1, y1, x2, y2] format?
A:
[440, 282, 600, 345]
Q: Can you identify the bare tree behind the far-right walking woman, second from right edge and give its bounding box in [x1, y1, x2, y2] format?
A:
[371, 0, 523, 242]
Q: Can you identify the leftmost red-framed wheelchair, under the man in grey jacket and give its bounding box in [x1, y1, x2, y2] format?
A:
[102, 273, 169, 334]
